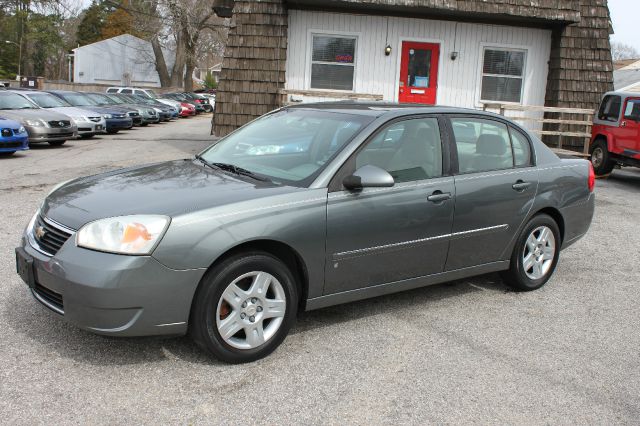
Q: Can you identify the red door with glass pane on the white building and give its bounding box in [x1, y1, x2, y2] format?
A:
[398, 41, 440, 105]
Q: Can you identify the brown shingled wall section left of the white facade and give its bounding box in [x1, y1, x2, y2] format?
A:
[212, 0, 288, 136]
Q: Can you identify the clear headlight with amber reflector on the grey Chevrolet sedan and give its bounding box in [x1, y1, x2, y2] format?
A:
[76, 215, 170, 255]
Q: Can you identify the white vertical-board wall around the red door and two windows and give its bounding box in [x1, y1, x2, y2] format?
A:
[285, 10, 551, 127]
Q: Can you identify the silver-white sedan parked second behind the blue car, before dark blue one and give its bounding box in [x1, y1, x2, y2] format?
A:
[11, 91, 107, 138]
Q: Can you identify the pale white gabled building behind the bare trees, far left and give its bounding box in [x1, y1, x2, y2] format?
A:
[73, 34, 174, 87]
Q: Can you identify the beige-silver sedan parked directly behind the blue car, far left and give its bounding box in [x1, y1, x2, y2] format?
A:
[0, 91, 78, 146]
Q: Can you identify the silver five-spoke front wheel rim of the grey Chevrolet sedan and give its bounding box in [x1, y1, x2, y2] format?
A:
[216, 271, 287, 349]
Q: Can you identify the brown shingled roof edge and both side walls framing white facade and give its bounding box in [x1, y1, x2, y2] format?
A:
[213, 0, 613, 136]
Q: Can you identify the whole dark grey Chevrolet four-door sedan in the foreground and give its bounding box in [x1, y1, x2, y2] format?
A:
[16, 103, 594, 363]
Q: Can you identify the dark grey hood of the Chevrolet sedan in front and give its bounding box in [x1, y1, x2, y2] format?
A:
[42, 160, 301, 229]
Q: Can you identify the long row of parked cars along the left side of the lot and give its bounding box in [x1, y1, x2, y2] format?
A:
[0, 87, 213, 156]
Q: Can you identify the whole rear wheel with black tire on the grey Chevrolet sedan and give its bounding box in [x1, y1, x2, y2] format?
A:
[501, 214, 562, 291]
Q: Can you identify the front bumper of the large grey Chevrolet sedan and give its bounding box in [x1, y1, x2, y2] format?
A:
[16, 230, 205, 336]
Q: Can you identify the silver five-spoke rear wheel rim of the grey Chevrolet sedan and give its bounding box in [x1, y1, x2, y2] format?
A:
[522, 226, 556, 280]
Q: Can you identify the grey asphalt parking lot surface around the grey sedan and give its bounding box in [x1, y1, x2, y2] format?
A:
[0, 115, 640, 424]
